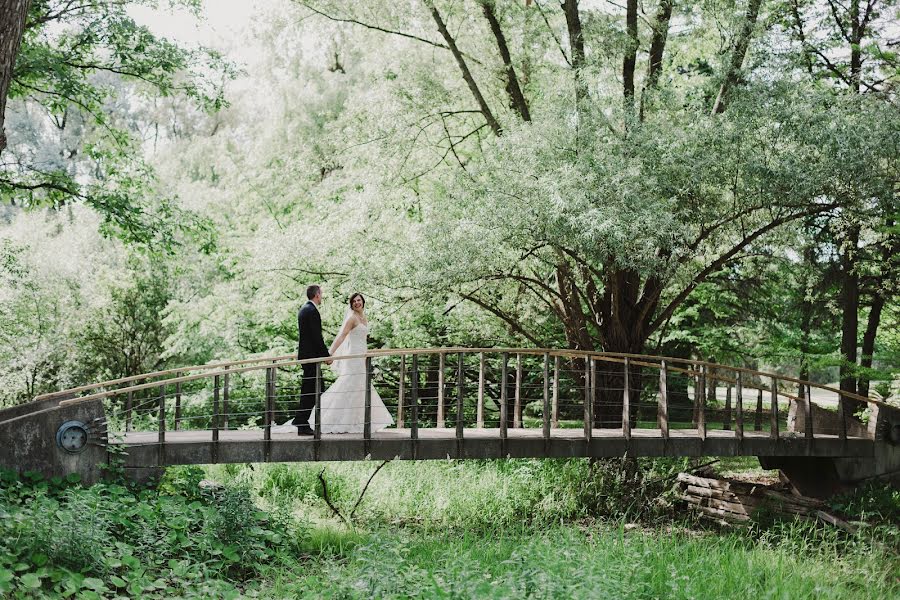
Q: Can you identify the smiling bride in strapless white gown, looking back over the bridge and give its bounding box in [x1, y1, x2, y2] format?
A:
[310, 292, 394, 433]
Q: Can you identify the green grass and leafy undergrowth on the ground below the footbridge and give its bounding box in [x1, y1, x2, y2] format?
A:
[0, 458, 900, 599]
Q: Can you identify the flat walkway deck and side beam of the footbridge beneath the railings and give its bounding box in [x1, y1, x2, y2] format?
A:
[113, 428, 874, 468]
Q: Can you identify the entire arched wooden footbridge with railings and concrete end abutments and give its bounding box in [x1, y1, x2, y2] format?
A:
[0, 348, 900, 494]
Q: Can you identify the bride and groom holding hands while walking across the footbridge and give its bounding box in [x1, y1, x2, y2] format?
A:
[273, 285, 394, 435]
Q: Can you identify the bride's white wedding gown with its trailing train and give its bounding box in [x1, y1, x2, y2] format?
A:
[272, 323, 394, 433]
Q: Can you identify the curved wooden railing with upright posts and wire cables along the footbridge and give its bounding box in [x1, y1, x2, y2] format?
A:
[52, 348, 884, 442]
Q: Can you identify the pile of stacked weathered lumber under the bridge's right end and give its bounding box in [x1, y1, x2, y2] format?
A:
[678, 473, 855, 533]
